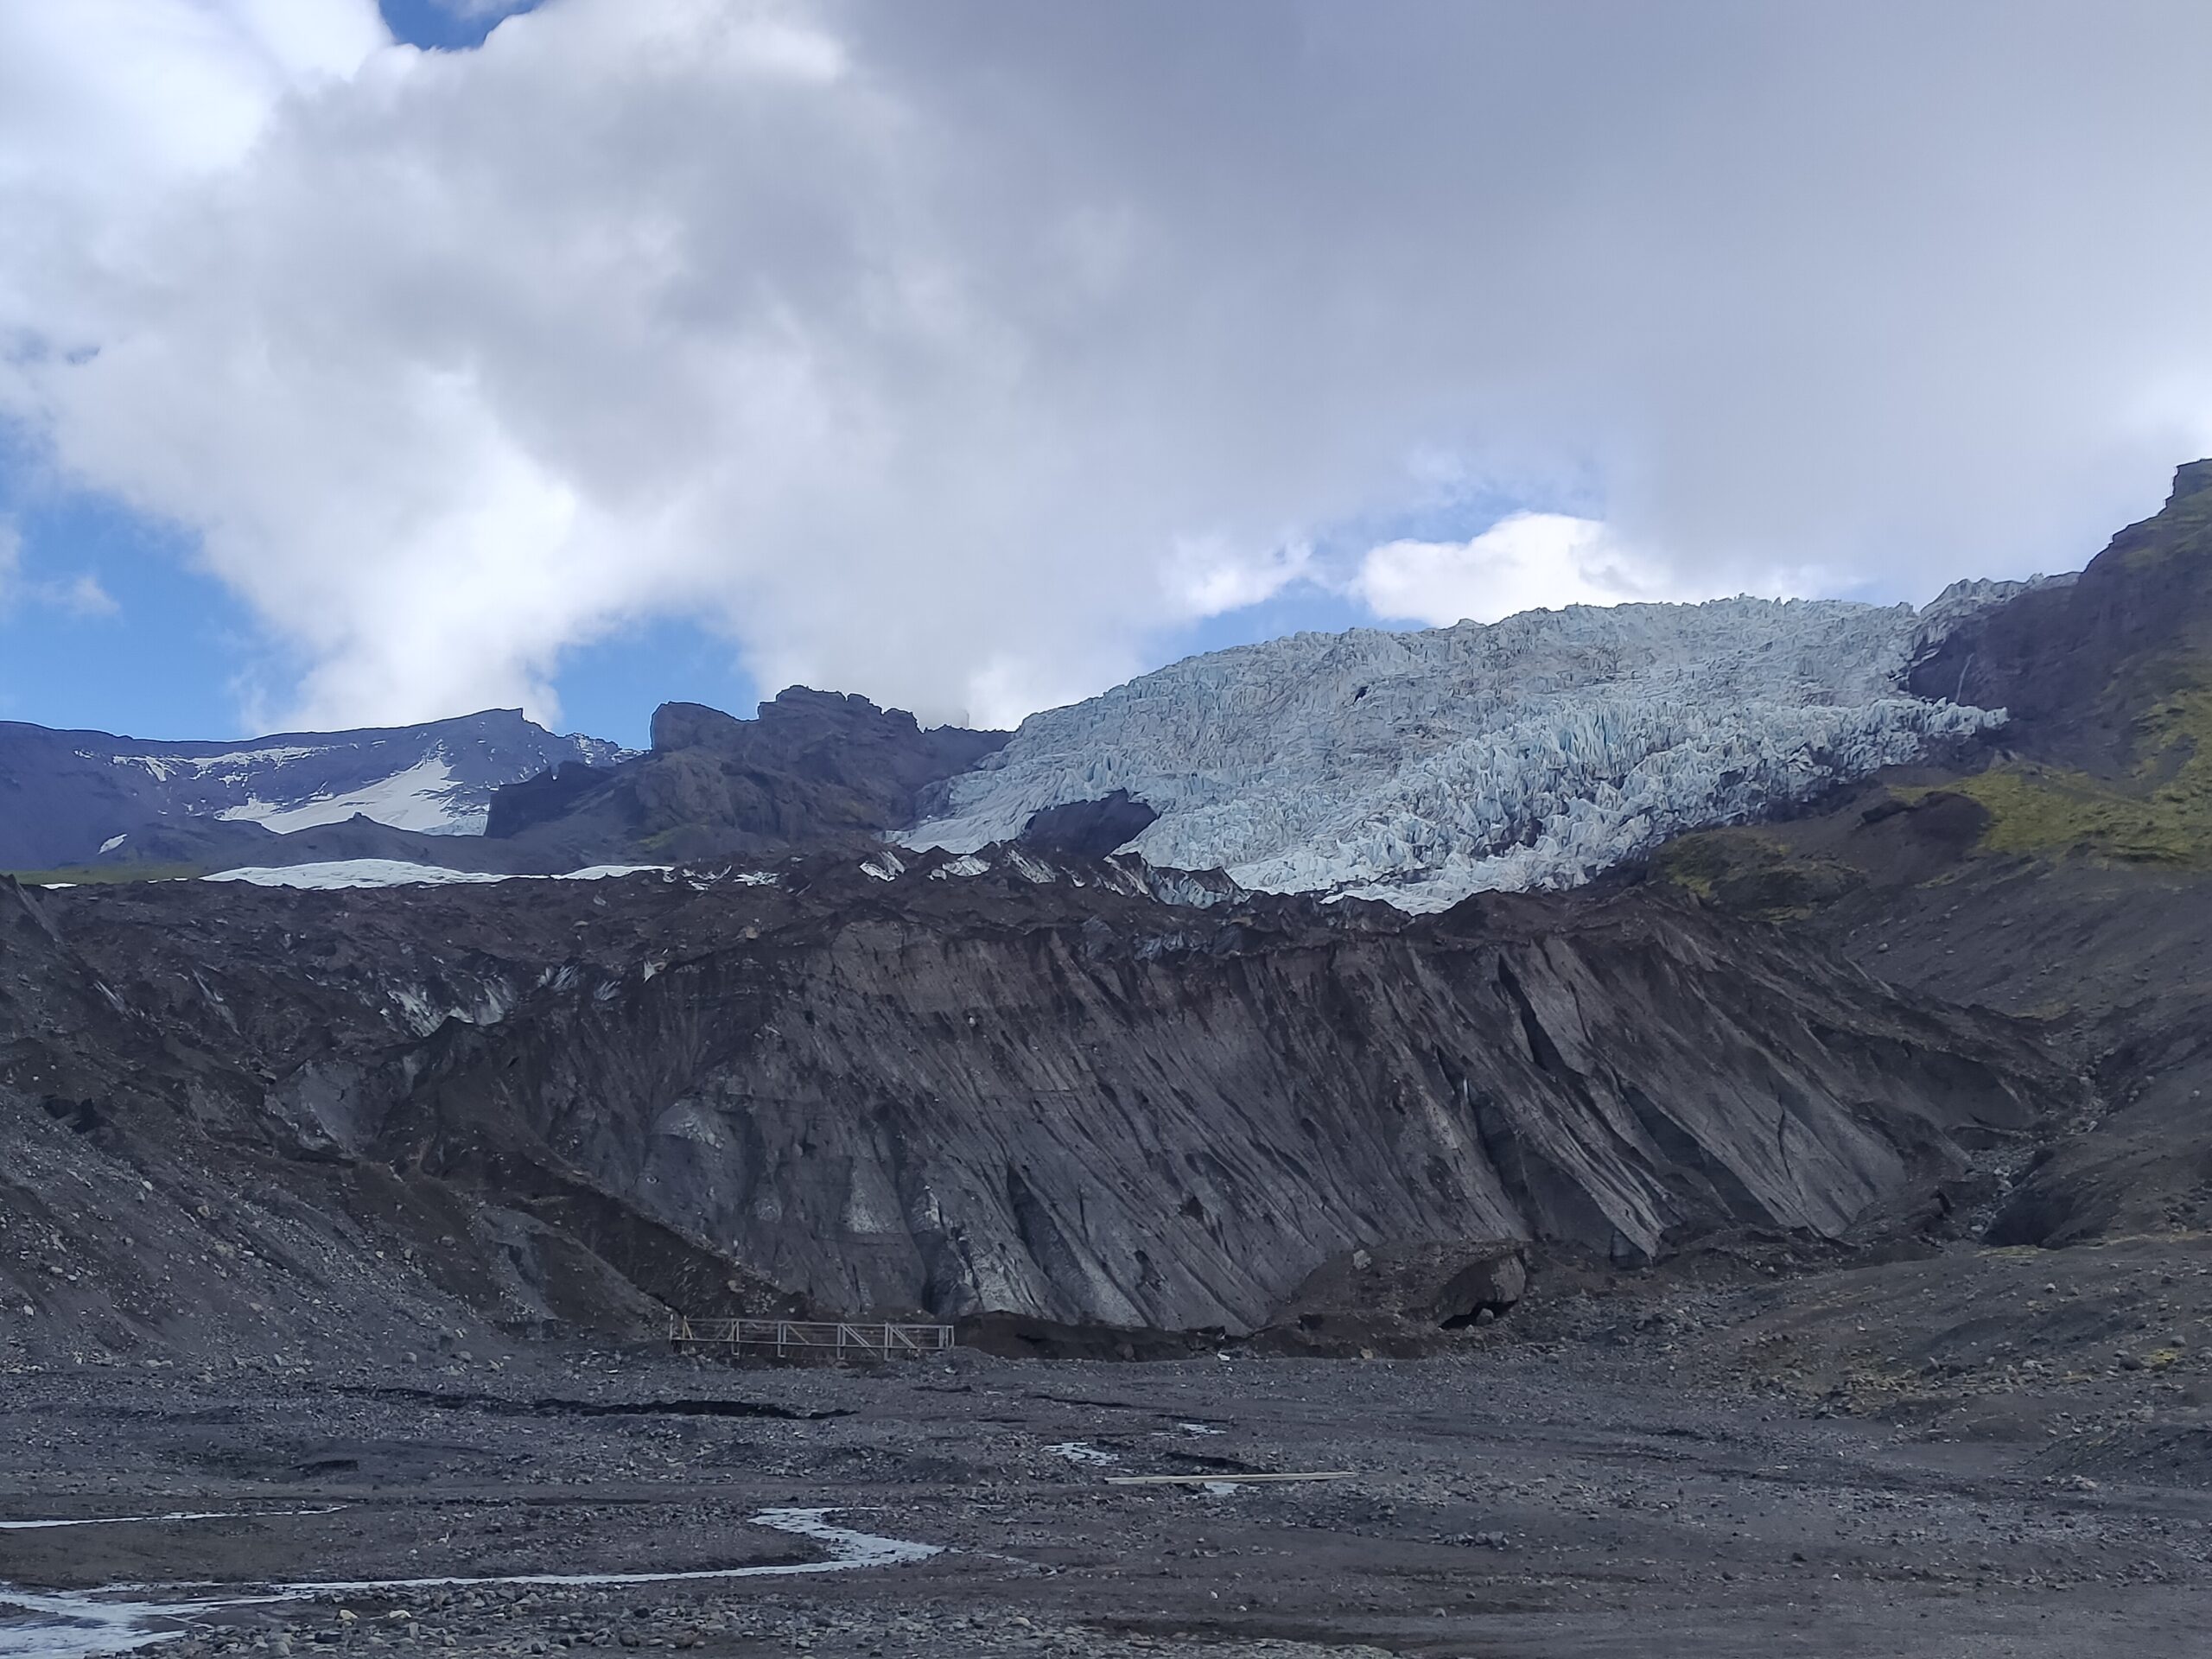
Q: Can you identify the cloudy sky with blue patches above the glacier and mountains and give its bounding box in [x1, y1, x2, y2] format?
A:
[0, 0, 2212, 741]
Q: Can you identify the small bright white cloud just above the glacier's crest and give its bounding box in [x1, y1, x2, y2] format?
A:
[1351, 513, 1706, 628]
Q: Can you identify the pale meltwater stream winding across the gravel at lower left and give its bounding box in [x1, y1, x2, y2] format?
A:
[0, 1509, 943, 1659]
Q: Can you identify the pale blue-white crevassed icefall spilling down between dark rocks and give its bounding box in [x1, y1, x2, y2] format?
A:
[907, 582, 2024, 909]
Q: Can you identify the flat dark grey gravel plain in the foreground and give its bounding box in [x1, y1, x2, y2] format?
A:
[0, 1309, 2212, 1659]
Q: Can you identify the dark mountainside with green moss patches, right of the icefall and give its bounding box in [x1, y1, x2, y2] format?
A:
[1655, 462, 2212, 1245]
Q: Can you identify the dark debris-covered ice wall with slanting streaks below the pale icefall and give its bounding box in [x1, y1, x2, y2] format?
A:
[7, 852, 2079, 1327]
